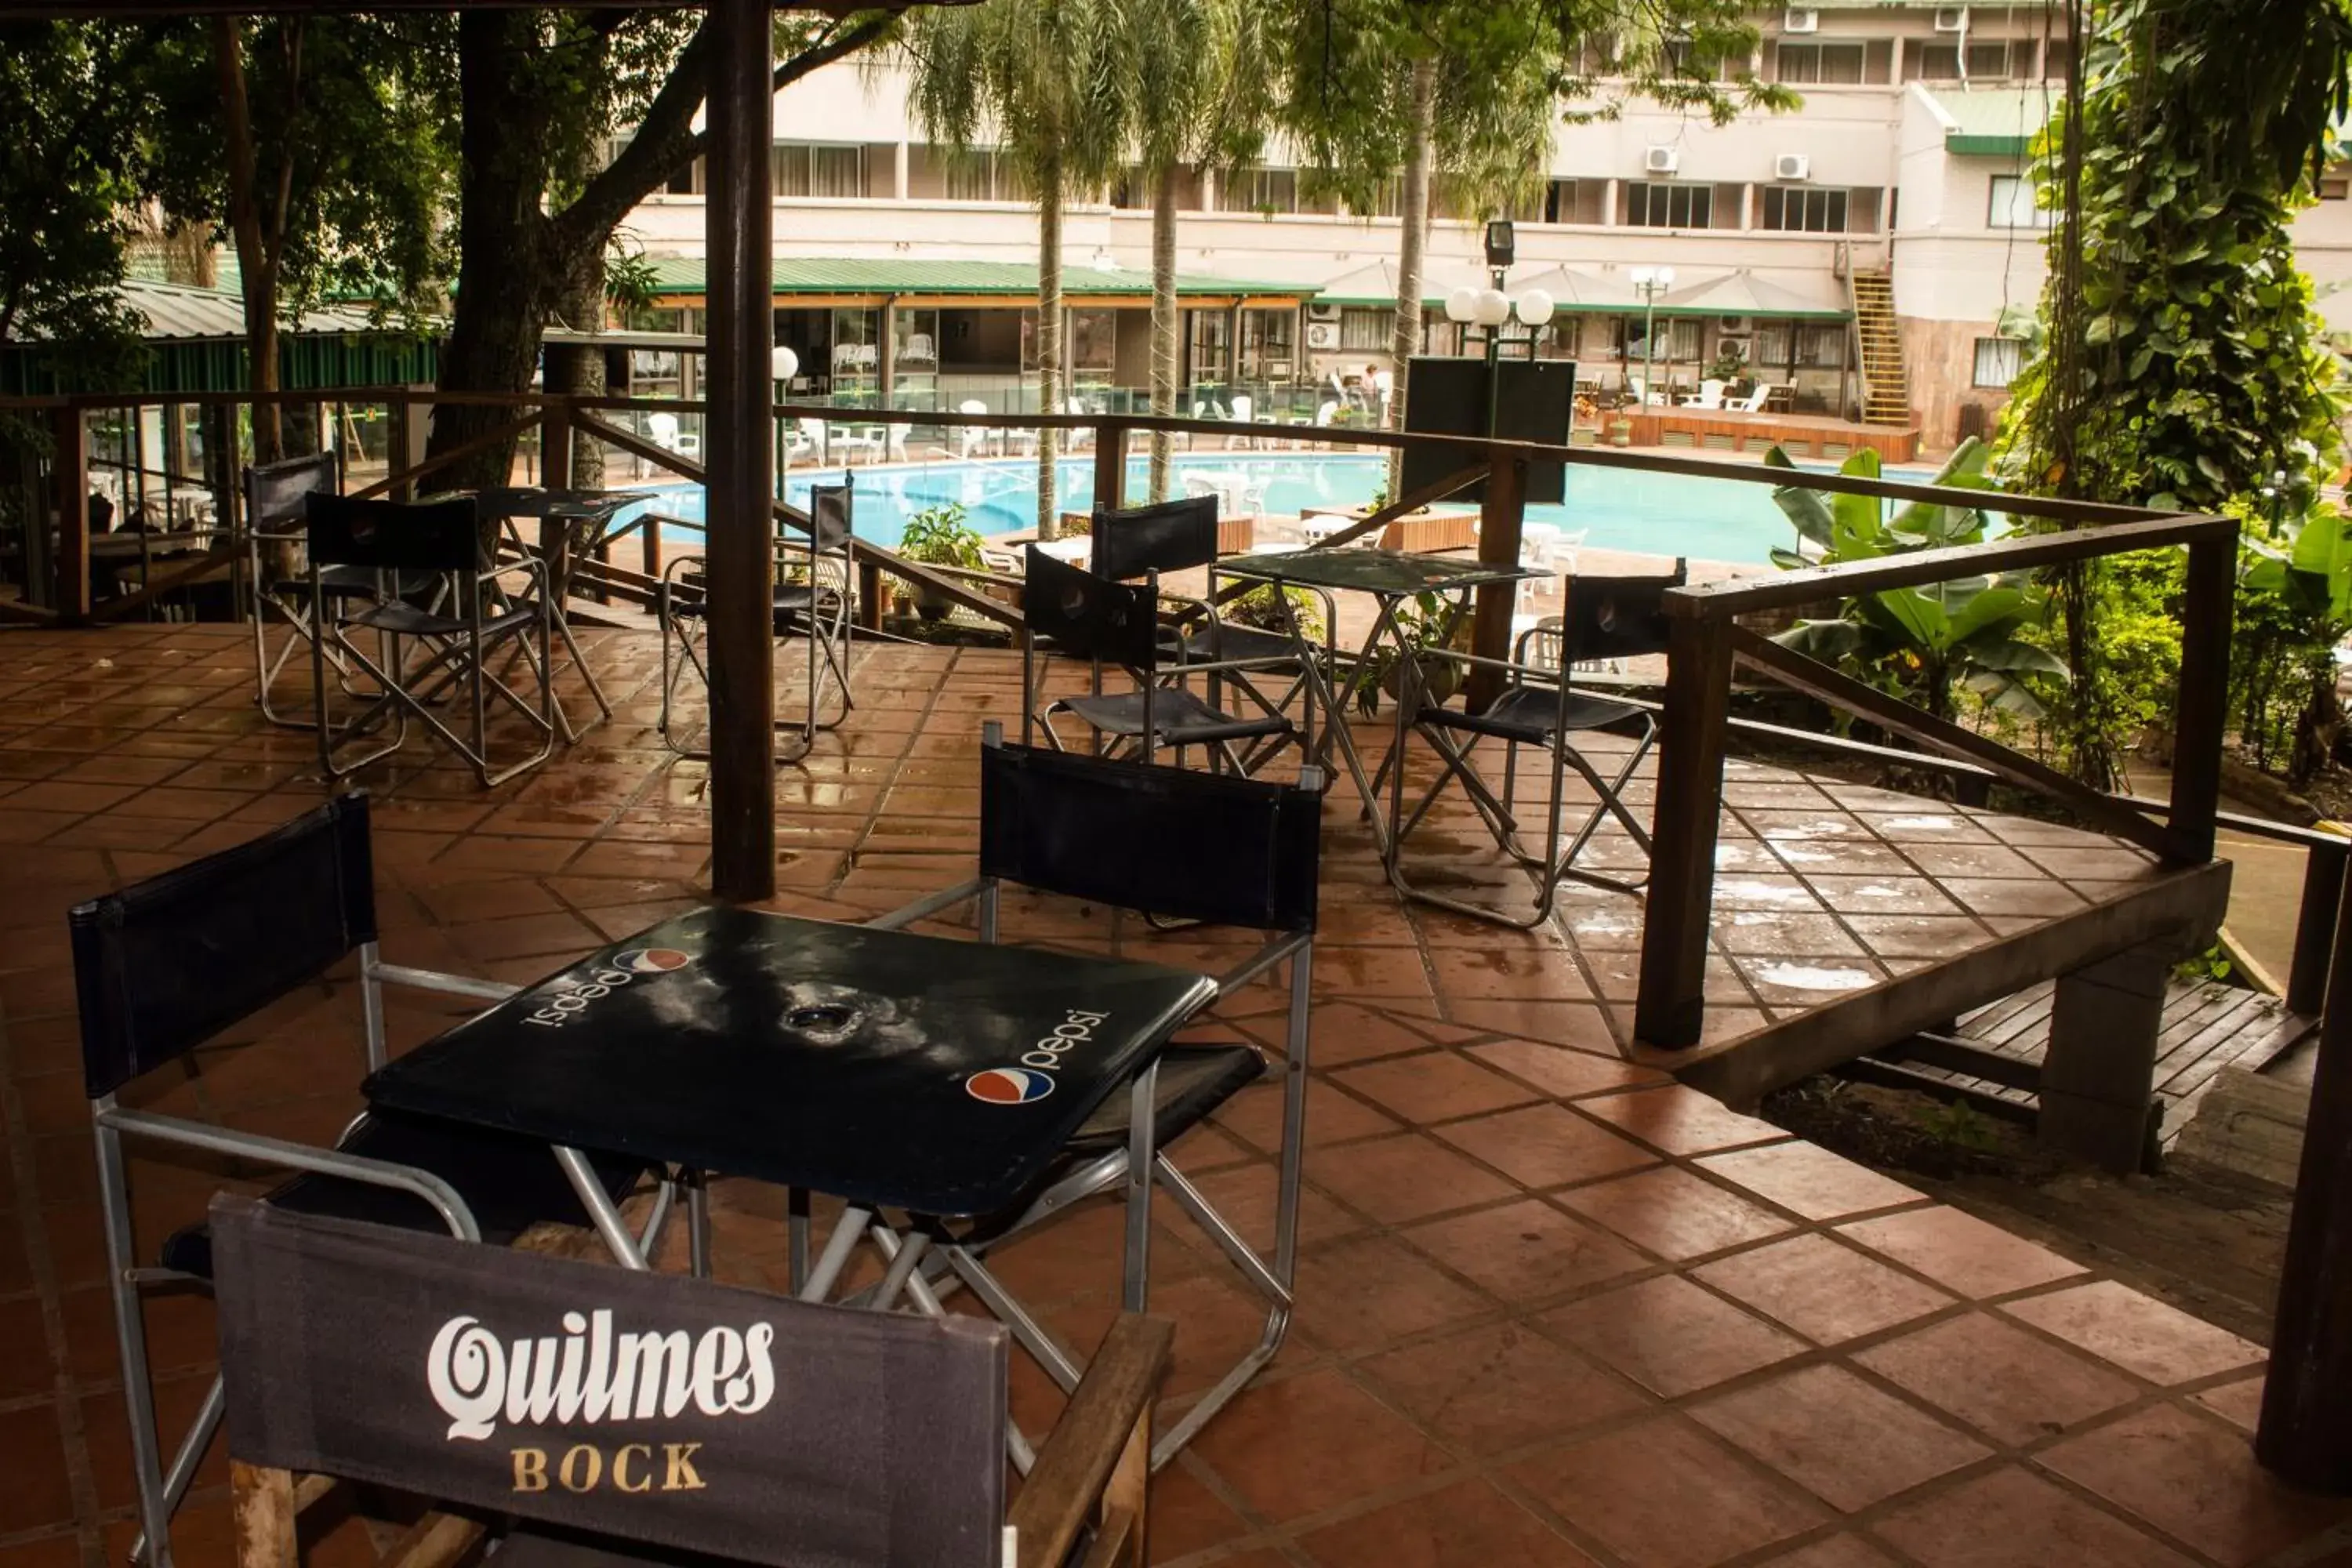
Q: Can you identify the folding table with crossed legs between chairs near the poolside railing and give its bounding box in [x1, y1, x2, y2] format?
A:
[1211, 550, 1545, 862]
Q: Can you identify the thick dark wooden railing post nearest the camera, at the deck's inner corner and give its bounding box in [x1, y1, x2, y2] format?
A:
[1632, 611, 1731, 1046]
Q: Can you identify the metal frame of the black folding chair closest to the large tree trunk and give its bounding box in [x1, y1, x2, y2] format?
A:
[308, 496, 557, 789]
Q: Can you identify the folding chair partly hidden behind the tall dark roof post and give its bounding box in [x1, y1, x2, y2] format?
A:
[647, 475, 856, 762]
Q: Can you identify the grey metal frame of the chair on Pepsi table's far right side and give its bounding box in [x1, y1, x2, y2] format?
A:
[870, 720, 1322, 1469]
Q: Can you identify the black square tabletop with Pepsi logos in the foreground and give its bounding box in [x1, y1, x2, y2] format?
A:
[367, 907, 1216, 1215]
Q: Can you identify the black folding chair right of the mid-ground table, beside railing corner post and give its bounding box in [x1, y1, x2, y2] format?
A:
[1390, 560, 1684, 928]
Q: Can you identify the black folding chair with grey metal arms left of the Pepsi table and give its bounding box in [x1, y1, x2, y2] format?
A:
[68, 794, 670, 1568]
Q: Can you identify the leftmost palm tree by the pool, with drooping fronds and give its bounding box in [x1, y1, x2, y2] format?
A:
[908, 0, 1136, 539]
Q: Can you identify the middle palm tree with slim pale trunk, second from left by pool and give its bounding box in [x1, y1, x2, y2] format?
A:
[1124, 0, 1275, 501]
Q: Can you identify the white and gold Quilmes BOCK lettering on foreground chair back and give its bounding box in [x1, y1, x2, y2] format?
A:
[426, 1309, 776, 1493]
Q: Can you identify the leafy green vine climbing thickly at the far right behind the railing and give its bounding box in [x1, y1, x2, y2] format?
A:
[2002, 0, 2352, 787]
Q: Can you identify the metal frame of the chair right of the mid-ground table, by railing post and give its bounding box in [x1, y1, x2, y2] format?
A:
[1388, 562, 1684, 931]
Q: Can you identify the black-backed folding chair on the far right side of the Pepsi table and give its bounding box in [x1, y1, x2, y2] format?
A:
[868, 724, 1322, 1467]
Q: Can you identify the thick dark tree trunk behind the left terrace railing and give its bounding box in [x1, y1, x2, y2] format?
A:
[426, 9, 557, 489]
